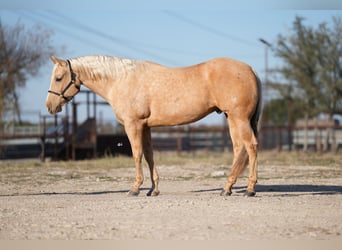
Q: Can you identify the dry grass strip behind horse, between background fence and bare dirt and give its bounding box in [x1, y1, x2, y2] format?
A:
[0, 151, 342, 193]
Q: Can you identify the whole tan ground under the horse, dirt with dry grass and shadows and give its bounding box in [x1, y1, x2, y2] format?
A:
[0, 150, 342, 240]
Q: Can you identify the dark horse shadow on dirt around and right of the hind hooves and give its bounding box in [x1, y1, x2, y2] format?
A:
[191, 184, 342, 196]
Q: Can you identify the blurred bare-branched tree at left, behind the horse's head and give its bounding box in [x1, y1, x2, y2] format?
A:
[0, 20, 53, 128]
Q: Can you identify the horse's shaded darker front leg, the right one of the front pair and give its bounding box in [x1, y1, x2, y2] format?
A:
[143, 127, 159, 196]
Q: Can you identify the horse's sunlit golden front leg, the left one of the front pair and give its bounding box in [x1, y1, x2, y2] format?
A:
[125, 122, 144, 196]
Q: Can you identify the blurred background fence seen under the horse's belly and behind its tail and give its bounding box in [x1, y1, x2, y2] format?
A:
[152, 125, 342, 151]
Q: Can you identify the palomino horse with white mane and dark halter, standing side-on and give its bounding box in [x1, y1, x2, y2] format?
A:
[46, 56, 261, 196]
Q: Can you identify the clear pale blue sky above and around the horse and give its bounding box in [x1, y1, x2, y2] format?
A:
[0, 0, 342, 124]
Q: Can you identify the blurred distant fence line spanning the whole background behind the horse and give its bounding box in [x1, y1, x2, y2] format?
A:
[0, 117, 342, 159]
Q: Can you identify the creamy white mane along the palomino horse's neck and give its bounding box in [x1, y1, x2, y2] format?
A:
[70, 56, 138, 81]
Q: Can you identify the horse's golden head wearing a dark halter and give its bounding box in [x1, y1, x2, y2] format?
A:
[46, 56, 81, 114]
